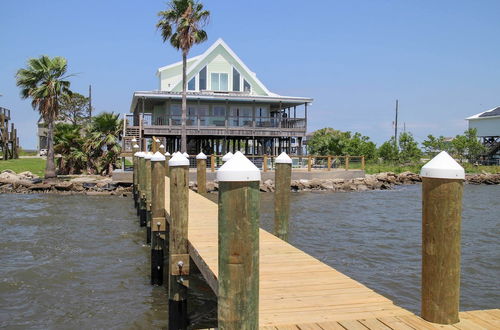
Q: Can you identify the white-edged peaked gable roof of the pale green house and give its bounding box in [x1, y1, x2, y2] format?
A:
[167, 38, 277, 96]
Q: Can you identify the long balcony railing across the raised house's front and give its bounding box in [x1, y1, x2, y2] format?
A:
[135, 113, 306, 128]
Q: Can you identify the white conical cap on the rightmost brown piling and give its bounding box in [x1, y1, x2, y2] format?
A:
[420, 151, 465, 179]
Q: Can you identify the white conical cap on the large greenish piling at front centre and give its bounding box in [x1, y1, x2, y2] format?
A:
[217, 151, 260, 181]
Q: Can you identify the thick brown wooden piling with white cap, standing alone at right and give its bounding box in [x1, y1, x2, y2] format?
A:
[420, 151, 465, 324]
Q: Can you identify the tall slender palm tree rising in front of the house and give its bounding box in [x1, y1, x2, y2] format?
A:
[156, 0, 210, 152]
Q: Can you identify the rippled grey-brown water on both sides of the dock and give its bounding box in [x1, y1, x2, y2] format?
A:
[0, 185, 500, 329]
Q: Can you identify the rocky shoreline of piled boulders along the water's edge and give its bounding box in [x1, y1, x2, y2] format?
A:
[0, 170, 500, 196]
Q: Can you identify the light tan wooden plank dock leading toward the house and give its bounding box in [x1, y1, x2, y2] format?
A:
[165, 177, 500, 329]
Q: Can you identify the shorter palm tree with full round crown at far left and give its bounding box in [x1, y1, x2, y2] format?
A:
[16, 55, 71, 179]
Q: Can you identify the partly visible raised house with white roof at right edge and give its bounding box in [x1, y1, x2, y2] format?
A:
[466, 107, 500, 164]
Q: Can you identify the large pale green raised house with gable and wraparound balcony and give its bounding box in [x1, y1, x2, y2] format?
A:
[124, 39, 312, 155]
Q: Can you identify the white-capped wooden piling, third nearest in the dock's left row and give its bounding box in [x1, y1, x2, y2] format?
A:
[151, 152, 166, 285]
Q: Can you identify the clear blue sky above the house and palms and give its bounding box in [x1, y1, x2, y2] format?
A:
[0, 0, 500, 148]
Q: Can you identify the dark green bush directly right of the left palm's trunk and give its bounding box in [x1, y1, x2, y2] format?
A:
[54, 123, 88, 174]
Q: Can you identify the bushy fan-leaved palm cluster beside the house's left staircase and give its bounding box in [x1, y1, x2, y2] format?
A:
[85, 112, 123, 175]
